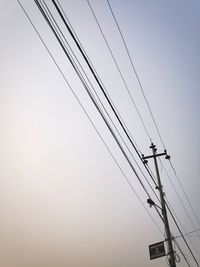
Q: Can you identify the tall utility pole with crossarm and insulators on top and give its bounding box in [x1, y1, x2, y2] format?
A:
[142, 143, 176, 267]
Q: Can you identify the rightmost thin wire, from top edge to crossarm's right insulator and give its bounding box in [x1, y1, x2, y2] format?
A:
[106, 0, 165, 149]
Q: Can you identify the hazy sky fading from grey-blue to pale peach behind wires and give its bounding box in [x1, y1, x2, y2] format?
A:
[0, 0, 200, 267]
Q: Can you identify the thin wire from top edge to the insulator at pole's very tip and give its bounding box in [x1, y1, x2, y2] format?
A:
[87, 0, 152, 142]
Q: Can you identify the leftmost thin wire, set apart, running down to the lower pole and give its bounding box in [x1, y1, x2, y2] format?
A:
[17, 0, 163, 235]
